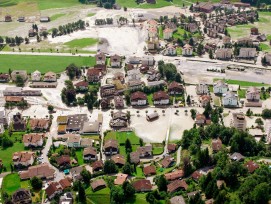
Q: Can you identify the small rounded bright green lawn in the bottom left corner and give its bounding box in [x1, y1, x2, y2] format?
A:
[2, 173, 21, 195]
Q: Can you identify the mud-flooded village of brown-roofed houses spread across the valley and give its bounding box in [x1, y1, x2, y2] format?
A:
[0, 1, 271, 204]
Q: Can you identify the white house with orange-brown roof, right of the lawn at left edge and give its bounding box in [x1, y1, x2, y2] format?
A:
[12, 152, 35, 167]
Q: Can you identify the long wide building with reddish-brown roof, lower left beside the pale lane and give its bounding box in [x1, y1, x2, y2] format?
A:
[19, 163, 55, 180]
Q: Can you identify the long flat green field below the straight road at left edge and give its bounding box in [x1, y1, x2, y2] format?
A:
[0, 55, 95, 73]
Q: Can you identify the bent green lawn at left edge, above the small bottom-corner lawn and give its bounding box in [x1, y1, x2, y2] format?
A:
[0, 142, 24, 171]
